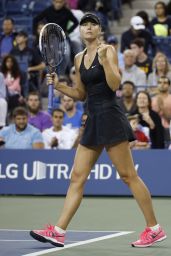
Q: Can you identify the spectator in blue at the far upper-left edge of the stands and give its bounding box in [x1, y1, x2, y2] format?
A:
[0, 17, 15, 58]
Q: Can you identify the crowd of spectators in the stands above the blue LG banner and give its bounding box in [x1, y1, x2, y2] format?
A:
[0, 0, 171, 150]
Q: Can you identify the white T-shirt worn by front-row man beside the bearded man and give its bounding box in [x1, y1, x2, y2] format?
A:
[42, 126, 78, 149]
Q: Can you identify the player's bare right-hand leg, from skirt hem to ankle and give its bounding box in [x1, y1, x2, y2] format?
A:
[106, 142, 157, 227]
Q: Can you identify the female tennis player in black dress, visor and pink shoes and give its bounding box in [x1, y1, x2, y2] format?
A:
[30, 13, 166, 247]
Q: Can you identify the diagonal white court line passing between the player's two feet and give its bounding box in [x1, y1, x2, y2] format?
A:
[22, 231, 134, 256]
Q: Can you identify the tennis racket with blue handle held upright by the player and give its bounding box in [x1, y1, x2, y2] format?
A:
[39, 23, 66, 113]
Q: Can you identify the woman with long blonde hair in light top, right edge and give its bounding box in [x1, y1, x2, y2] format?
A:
[147, 52, 171, 86]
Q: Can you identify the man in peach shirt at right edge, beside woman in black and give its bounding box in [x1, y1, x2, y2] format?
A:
[152, 76, 171, 144]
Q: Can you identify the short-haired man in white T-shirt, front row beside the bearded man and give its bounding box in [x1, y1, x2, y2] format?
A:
[42, 109, 78, 149]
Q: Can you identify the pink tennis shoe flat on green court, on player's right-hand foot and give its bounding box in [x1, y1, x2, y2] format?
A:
[132, 227, 167, 247]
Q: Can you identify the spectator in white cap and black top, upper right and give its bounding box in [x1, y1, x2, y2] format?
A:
[121, 16, 154, 53]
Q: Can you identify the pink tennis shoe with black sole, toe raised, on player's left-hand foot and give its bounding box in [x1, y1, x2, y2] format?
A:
[30, 225, 65, 247]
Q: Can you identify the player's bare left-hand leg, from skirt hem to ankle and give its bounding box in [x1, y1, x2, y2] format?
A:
[57, 145, 103, 230]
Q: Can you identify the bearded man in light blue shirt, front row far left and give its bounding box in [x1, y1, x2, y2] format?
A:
[0, 107, 44, 149]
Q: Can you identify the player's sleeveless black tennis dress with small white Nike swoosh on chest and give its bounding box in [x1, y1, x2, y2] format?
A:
[80, 51, 135, 146]
